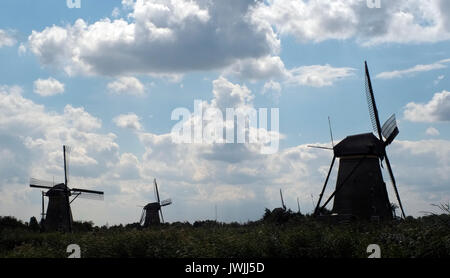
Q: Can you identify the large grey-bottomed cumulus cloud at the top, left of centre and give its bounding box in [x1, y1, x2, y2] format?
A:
[28, 0, 279, 76]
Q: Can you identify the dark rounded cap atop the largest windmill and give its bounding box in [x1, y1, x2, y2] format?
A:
[334, 133, 384, 157]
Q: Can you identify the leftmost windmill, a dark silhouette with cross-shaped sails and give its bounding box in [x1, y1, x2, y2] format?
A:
[30, 146, 103, 232]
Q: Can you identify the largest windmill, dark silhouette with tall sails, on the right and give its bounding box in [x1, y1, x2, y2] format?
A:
[314, 62, 405, 219]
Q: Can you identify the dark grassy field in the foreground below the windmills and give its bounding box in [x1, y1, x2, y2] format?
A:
[0, 210, 450, 258]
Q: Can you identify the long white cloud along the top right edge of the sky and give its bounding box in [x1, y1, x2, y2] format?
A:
[254, 0, 450, 45]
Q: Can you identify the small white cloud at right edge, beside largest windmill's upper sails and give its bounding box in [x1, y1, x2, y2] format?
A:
[404, 90, 450, 123]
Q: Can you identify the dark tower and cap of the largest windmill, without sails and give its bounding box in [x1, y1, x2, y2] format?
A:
[332, 133, 392, 219]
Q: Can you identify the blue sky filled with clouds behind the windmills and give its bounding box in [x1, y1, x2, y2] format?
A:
[0, 0, 450, 225]
